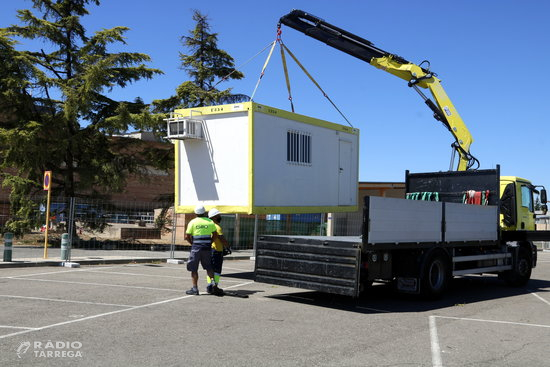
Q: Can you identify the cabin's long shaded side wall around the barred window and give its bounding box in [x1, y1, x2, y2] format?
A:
[254, 112, 358, 207]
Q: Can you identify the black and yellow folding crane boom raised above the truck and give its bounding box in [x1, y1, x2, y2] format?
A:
[280, 9, 479, 171]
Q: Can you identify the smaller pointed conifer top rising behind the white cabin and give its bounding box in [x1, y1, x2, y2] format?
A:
[153, 10, 248, 113]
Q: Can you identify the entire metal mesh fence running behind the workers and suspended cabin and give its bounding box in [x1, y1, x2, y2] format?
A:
[0, 195, 361, 258]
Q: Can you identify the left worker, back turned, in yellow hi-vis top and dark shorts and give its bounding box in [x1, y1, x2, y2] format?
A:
[185, 205, 223, 296]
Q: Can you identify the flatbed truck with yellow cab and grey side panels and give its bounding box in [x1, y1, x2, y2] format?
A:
[255, 166, 550, 297]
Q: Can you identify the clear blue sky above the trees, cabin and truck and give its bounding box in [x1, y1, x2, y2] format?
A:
[0, 0, 550, 189]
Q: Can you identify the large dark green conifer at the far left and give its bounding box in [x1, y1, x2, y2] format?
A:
[0, 0, 161, 201]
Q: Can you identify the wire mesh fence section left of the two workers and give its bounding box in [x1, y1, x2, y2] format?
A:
[0, 195, 173, 261]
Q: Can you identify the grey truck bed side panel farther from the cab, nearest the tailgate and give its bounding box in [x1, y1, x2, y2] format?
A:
[368, 196, 442, 243]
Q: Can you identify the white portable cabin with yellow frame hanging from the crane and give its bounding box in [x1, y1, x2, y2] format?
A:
[167, 102, 359, 214]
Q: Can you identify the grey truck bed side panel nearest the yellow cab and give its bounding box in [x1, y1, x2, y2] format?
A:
[445, 203, 498, 242]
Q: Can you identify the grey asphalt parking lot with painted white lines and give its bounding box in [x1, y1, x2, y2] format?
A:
[0, 252, 550, 367]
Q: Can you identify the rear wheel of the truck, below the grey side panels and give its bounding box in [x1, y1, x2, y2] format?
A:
[420, 252, 451, 298]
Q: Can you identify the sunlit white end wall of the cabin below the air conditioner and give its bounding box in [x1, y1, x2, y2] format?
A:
[178, 112, 249, 206]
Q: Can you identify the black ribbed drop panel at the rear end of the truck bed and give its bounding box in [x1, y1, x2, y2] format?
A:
[255, 236, 361, 297]
